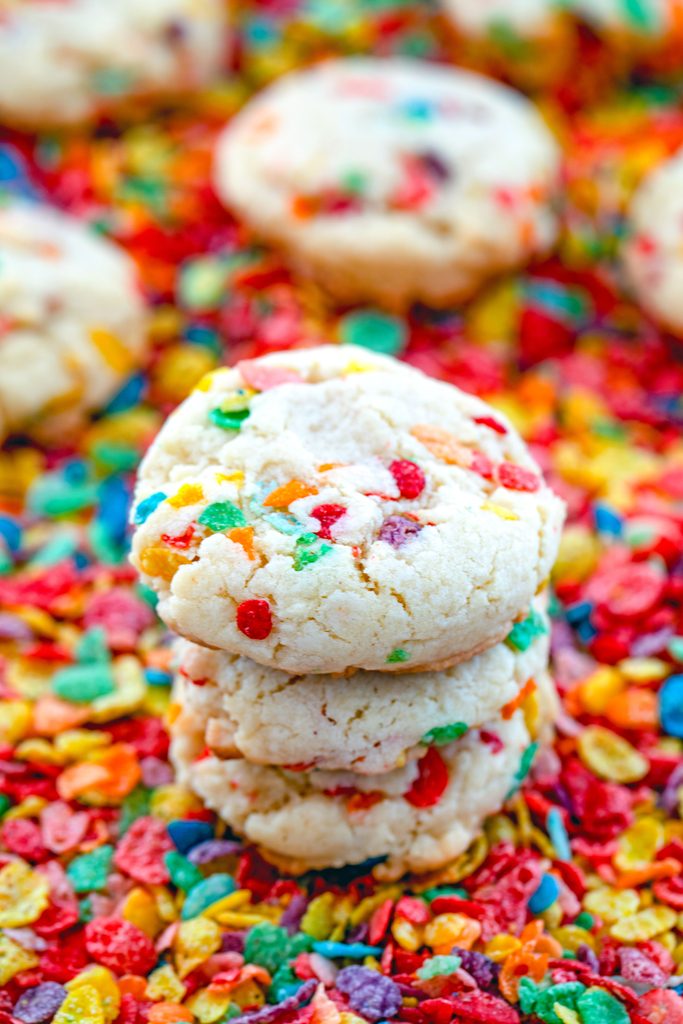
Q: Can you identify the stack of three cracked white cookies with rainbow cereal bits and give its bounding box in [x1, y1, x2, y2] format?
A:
[133, 346, 563, 878]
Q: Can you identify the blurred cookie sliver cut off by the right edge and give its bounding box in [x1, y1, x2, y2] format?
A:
[624, 152, 683, 334]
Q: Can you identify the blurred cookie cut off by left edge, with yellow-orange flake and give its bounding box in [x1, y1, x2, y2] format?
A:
[0, 201, 145, 440]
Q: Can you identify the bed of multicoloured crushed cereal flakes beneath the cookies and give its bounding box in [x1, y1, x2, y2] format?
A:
[0, 0, 683, 1024]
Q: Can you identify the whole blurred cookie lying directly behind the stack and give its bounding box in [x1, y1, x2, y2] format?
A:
[215, 57, 559, 308]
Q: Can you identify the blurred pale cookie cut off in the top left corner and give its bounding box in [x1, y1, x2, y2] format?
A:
[0, 0, 227, 127]
